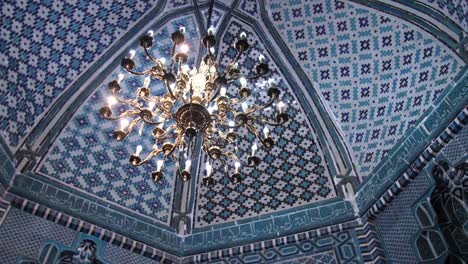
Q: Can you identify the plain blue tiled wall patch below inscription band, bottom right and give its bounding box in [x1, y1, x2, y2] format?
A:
[375, 168, 431, 263]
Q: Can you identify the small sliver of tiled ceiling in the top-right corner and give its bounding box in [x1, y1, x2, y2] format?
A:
[418, 0, 468, 29]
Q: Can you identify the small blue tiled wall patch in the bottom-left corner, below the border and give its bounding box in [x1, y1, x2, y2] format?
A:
[0, 208, 76, 263]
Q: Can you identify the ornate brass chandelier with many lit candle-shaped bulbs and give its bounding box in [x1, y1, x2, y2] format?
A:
[100, 22, 288, 185]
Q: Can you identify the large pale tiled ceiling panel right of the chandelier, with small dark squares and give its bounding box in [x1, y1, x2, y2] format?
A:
[268, 0, 464, 176]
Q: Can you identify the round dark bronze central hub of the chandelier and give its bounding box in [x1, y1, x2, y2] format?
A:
[176, 103, 211, 131]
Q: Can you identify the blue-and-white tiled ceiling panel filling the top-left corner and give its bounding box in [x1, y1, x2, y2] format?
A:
[0, 0, 155, 149]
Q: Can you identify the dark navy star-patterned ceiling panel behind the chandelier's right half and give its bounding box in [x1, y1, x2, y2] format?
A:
[195, 19, 337, 227]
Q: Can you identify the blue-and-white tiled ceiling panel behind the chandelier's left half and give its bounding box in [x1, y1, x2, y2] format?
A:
[34, 16, 198, 223]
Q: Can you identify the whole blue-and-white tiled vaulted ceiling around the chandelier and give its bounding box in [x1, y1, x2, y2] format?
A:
[0, 0, 468, 258]
